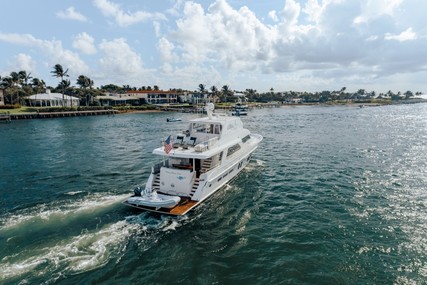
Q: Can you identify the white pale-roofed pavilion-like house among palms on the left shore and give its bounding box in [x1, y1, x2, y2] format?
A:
[25, 89, 80, 107]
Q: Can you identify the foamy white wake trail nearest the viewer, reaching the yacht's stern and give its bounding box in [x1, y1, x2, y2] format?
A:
[0, 209, 190, 283]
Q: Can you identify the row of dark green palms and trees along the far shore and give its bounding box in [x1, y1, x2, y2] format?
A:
[0, 64, 421, 106]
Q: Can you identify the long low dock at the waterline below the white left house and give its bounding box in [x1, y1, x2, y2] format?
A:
[7, 110, 118, 120]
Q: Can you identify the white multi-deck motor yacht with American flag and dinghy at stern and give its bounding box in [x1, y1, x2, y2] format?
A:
[123, 103, 263, 215]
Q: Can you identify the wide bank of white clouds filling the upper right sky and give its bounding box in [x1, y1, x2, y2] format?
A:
[159, 0, 427, 91]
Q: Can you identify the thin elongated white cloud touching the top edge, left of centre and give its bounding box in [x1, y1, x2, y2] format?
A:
[93, 0, 166, 27]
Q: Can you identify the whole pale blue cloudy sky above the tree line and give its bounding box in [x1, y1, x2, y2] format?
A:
[0, 0, 427, 93]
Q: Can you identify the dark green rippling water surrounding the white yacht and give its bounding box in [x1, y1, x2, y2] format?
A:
[0, 104, 427, 284]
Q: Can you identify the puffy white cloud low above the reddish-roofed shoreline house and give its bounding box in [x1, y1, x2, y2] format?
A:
[99, 38, 143, 80]
